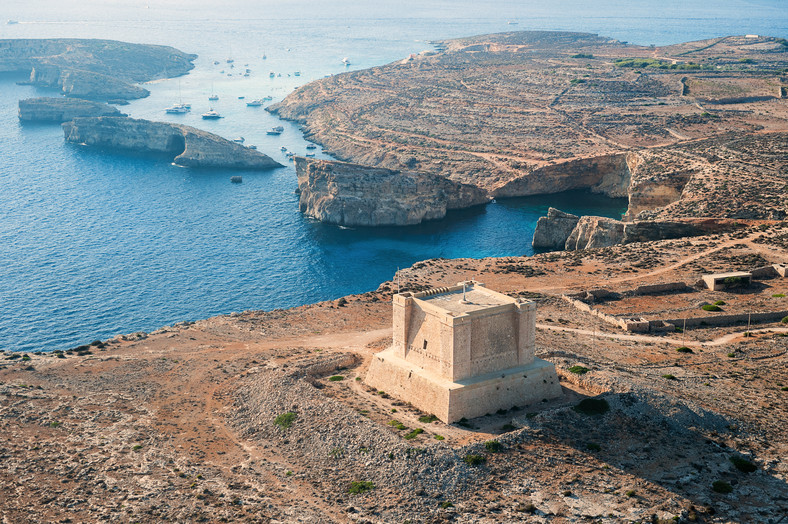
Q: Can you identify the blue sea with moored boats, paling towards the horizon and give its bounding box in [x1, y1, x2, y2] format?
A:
[0, 0, 788, 351]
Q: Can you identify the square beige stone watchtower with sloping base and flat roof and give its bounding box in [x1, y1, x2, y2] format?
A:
[366, 281, 561, 423]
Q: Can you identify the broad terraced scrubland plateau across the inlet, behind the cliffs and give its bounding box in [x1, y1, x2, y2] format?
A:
[270, 32, 788, 229]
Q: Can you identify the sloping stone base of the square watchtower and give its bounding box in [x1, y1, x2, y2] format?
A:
[365, 349, 561, 424]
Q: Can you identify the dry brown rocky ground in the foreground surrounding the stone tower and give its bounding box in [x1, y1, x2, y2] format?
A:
[0, 223, 788, 524]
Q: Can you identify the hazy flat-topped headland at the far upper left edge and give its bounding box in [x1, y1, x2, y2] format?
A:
[0, 38, 197, 100]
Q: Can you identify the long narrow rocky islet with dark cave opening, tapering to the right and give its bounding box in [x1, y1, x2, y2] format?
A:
[63, 117, 282, 169]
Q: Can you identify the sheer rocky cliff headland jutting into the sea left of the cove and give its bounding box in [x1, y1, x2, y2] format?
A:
[296, 158, 489, 226]
